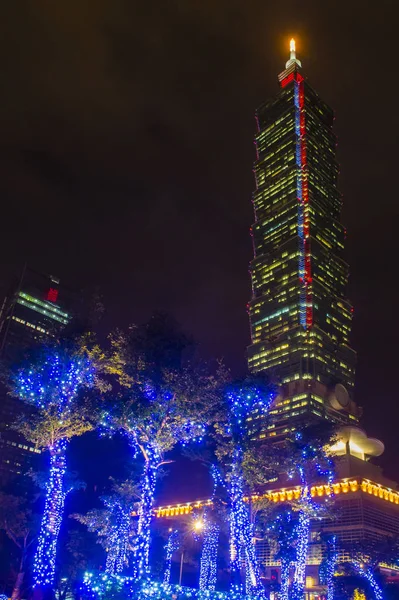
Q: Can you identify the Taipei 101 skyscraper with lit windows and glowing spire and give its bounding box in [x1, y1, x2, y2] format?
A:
[248, 40, 360, 438]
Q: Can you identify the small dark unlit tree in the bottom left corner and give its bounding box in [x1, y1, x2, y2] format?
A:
[0, 492, 38, 600]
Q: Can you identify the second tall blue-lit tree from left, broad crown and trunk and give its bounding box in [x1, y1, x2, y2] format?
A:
[102, 315, 227, 578]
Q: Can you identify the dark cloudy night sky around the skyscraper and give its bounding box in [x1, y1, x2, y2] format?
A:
[0, 0, 399, 477]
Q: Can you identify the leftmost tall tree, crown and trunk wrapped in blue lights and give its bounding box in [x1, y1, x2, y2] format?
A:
[12, 343, 94, 596]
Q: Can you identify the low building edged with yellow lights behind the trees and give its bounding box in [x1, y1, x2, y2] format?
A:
[155, 427, 399, 599]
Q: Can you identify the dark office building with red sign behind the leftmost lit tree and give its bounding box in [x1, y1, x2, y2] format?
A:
[0, 269, 70, 478]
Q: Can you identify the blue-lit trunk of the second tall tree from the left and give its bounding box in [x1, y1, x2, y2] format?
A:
[133, 447, 160, 579]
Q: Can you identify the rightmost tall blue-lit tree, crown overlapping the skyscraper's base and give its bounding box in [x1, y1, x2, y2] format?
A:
[248, 423, 340, 600]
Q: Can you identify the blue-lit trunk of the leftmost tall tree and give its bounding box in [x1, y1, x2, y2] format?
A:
[33, 440, 67, 599]
